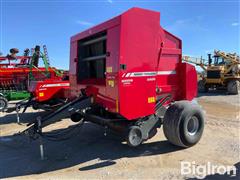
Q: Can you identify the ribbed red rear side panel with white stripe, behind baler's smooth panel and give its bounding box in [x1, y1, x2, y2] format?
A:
[157, 27, 182, 99]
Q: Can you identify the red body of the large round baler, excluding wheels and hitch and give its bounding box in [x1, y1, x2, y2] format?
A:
[70, 8, 196, 120]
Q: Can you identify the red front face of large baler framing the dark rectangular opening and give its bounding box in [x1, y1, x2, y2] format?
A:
[69, 17, 120, 112]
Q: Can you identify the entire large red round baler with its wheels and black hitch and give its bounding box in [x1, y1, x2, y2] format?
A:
[24, 8, 204, 156]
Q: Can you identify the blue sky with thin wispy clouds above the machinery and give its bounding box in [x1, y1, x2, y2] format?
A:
[0, 0, 240, 69]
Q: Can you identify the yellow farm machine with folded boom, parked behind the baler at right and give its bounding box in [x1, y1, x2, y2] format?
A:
[182, 50, 240, 94]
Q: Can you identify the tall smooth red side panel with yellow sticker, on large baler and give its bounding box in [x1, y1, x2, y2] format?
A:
[119, 8, 160, 120]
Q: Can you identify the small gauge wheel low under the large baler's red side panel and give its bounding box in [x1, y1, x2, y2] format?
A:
[127, 126, 143, 147]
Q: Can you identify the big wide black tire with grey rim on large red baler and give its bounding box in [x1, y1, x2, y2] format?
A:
[163, 101, 204, 148]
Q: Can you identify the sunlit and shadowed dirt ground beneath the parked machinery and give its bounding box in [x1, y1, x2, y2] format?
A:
[0, 92, 240, 179]
